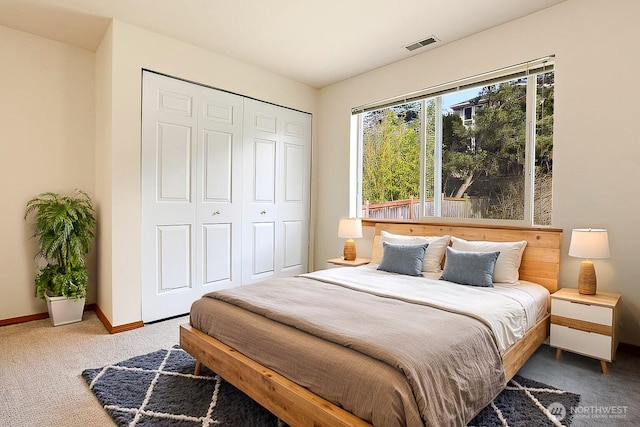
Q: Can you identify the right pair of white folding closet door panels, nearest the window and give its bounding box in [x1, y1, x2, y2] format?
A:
[242, 99, 311, 284]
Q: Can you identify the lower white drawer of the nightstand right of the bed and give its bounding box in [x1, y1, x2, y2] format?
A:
[549, 325, 612, 362]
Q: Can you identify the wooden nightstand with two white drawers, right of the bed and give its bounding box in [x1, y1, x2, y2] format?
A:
[549, 288, 620, 375]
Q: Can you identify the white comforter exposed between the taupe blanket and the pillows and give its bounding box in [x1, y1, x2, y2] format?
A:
[302, 264, 549, 352]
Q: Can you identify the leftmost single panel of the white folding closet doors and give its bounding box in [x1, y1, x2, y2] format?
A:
[142, 73, 198, 322]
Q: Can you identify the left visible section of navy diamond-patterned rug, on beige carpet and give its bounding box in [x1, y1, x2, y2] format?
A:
[82, 346, 278, 427]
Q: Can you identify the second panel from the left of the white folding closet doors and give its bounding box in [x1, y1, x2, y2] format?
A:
[196, 88, 242, 296]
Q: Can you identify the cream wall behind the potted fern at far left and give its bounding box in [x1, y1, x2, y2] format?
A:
[0, 26, 96, 320]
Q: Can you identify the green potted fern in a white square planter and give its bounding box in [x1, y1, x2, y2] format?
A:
[24, 191, 96, 326]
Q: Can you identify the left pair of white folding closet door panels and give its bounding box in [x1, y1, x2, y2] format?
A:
[142, 72, 242, 322]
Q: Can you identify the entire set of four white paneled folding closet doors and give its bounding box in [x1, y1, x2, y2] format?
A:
[142, 71, 311, 322]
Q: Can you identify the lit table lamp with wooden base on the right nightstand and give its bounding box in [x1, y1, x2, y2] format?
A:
[569, 228, 609, 295]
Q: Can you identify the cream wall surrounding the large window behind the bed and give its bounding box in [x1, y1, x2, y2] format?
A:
[315, 0, 640, 345]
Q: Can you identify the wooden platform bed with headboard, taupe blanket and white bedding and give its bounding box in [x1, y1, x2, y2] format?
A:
[180, 223, 562, 426]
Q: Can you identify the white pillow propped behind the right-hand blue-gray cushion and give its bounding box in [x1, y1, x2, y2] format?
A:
[451, 236, 527, 283]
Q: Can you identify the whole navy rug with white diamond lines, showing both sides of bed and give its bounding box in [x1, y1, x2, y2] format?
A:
[82, 346, 580, 427]
